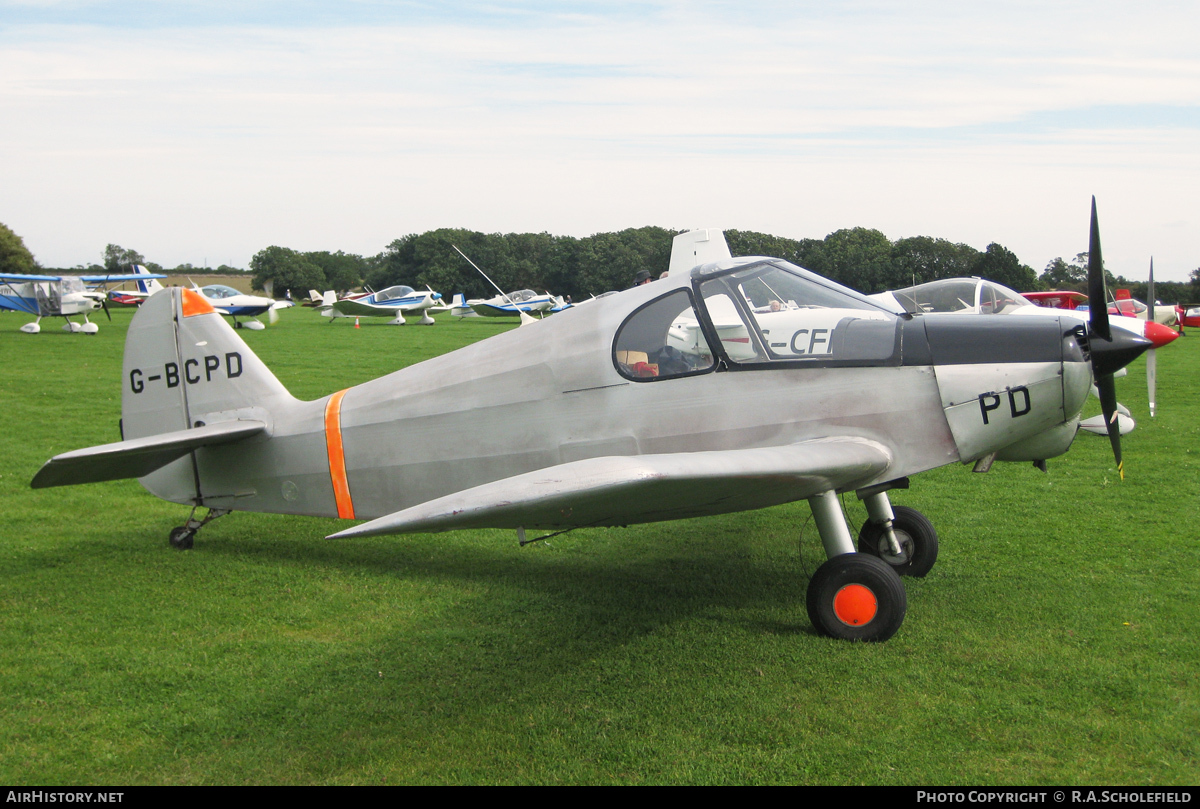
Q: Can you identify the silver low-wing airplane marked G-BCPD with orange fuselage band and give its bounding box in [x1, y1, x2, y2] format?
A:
[32, 203, 1151, 641]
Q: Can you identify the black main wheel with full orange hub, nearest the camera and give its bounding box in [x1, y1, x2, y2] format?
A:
[805, 553, 908, 642]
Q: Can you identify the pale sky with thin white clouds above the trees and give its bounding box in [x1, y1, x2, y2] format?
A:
[0, 0, 1200, 281]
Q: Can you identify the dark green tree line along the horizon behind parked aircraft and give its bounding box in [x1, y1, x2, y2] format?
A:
[0, 218, 1200, 302]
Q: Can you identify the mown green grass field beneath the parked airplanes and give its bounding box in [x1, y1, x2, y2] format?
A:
[0, 302, 1200, 785]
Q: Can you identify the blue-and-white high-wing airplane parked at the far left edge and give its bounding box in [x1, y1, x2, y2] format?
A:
[0, 274, 167, 334]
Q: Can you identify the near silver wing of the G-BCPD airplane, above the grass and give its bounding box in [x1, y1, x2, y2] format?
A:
[330, 437, 892, 539]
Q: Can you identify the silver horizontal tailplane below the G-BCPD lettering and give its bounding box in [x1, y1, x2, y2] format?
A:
[30, 419, 266, 489]
